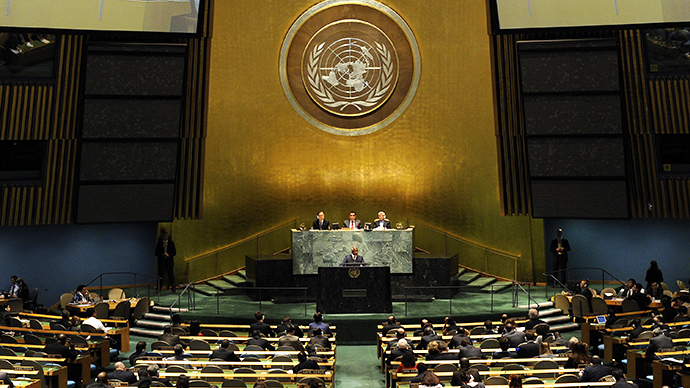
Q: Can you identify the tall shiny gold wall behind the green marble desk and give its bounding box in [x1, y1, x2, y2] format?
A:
[172, 0, 544, 280]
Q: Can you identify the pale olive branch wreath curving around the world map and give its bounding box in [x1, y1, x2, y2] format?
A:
[307, 42, 393, 111]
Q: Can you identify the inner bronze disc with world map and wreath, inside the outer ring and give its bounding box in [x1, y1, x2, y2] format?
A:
[302, 20, 398, 116]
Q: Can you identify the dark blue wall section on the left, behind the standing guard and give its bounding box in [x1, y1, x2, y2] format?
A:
[0, 223, 158, 306]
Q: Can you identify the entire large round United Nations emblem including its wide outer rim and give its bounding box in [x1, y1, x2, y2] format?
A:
[280, 0, 420, 135]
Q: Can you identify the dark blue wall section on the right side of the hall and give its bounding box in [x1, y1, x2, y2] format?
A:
[538, 219, 690, 291]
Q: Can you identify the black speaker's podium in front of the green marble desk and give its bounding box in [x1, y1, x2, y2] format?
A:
[316, 267, 393, 314]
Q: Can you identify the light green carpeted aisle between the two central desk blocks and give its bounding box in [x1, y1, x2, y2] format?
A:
[335, 345, 386, 388]
